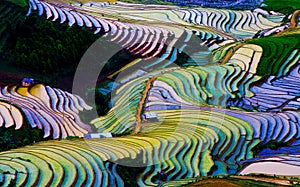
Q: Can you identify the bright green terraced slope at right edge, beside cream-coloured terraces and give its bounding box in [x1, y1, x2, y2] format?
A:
[247, 34, 300, 76]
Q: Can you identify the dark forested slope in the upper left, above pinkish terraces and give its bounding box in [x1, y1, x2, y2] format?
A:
[0, 1, 99, 89]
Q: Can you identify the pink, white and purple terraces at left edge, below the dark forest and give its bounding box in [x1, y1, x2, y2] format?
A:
[0, 84, 91, 139]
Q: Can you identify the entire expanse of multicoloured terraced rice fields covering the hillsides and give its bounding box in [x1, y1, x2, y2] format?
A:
[0, 0, 300, 186]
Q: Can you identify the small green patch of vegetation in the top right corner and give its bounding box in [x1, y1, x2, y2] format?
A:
[263, 0, 300, 15]
